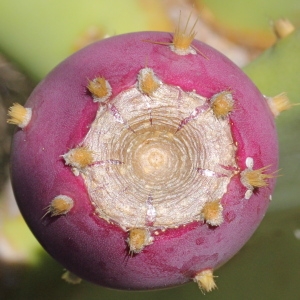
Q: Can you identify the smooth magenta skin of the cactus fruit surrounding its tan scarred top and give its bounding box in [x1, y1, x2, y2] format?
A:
[11, 32, 278, 290]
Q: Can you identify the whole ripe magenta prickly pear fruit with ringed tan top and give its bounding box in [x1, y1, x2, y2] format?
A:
[8, 31, 278, 292]
